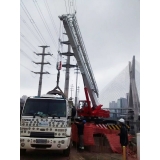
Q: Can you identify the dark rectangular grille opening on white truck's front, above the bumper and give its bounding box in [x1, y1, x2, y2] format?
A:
[30, 132, 54, 138]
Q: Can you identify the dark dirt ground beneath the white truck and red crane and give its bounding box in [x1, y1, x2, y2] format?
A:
[20, 147, 137, 160]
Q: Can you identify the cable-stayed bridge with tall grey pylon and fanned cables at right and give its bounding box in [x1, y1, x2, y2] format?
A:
[99, 56, 140, 131]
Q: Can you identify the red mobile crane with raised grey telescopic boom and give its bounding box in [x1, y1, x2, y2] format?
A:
[59, 14, 130, 148]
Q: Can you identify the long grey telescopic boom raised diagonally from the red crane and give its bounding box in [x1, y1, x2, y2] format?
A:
[59, 14, 100, 107]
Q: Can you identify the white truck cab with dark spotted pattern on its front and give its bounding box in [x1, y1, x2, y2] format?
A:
[20, 94, 72, 156]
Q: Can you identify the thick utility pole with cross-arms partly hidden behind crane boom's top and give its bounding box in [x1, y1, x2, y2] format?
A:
[61, 38, 76, 98]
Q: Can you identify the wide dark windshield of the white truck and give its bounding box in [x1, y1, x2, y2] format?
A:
[22, 99, 66, 117]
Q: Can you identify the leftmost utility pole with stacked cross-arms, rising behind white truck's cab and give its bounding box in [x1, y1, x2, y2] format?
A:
[32, 46, 52, 96]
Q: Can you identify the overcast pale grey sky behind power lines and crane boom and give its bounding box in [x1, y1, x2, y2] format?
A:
[20, 0, 140, 102]
